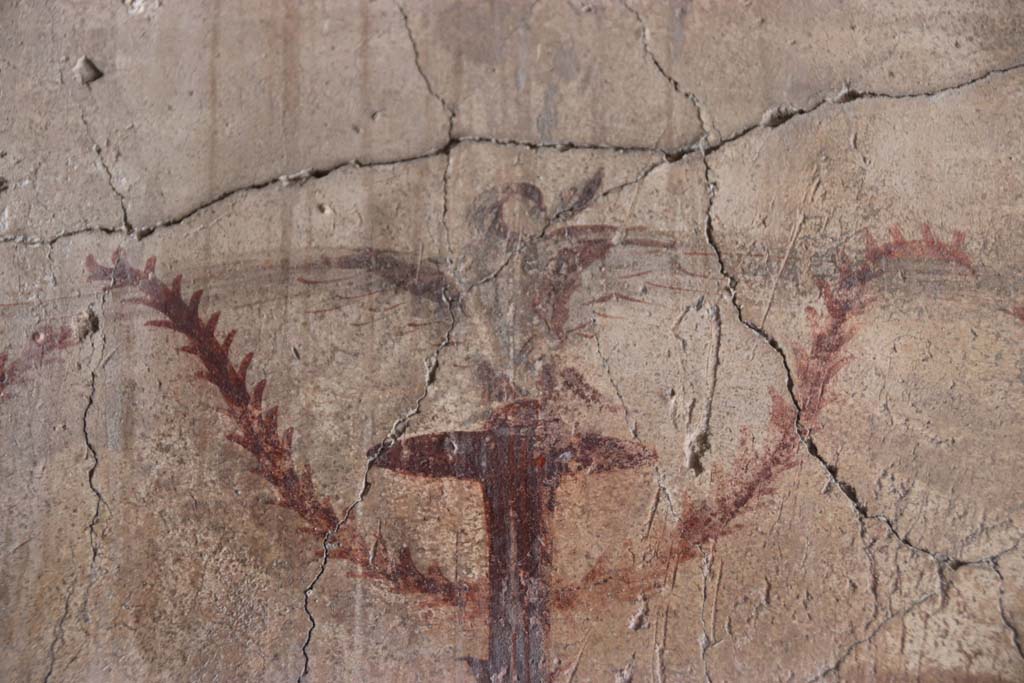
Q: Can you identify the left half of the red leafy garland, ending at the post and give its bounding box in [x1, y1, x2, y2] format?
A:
[86, 251, 472, 604]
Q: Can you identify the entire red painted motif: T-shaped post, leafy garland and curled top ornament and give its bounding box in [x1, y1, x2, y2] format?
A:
[86, 175, 973, 683]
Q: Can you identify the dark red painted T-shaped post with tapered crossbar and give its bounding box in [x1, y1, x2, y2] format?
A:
[371, 399, 654, 683]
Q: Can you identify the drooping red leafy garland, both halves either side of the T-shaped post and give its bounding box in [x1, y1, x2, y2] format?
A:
[87, 227, 973, 604]
